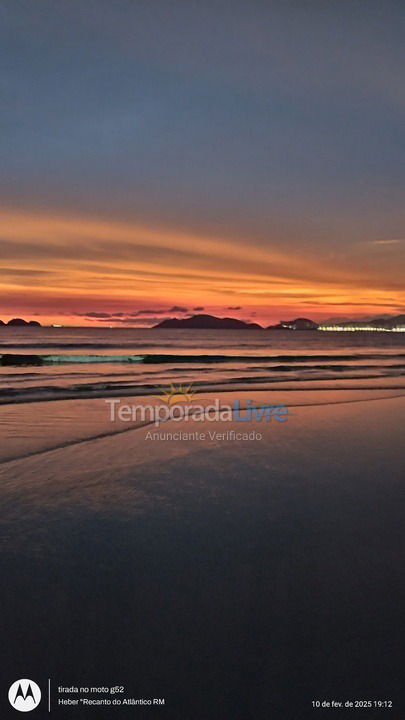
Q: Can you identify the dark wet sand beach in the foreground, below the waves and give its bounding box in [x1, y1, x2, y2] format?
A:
[0, 389, 405, 720]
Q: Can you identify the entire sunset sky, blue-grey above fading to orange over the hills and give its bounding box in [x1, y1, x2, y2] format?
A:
[0, 0, 405, 327]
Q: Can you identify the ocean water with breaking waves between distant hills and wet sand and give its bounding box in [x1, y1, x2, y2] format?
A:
[0, 328, 405, 403]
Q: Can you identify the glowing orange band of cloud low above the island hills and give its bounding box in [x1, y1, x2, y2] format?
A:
[0, 210, 405, 326]
